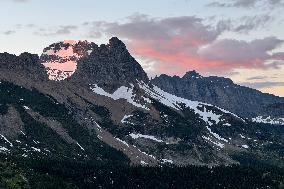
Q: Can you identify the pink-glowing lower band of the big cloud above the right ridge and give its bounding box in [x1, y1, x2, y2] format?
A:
[127, 38, 284, 75]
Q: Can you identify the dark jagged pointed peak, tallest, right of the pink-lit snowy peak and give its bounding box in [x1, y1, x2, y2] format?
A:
[71, 37, 148, 91]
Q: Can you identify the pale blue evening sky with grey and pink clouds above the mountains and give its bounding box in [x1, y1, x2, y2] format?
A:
[0, 0, 284, 97]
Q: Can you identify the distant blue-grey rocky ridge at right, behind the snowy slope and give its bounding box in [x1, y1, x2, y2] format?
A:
[151, 71, 284, 118]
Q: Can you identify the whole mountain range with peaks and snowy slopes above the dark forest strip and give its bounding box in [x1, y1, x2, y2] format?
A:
[0, 37, 284, 188]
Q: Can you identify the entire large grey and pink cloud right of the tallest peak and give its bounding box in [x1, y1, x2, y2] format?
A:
[90, 15, 284, 75]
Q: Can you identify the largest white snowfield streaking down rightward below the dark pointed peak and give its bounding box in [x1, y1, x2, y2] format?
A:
[90, 81, 244, 126]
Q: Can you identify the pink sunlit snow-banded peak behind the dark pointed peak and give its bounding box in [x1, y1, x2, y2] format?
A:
[40, 40, 96, 81]
